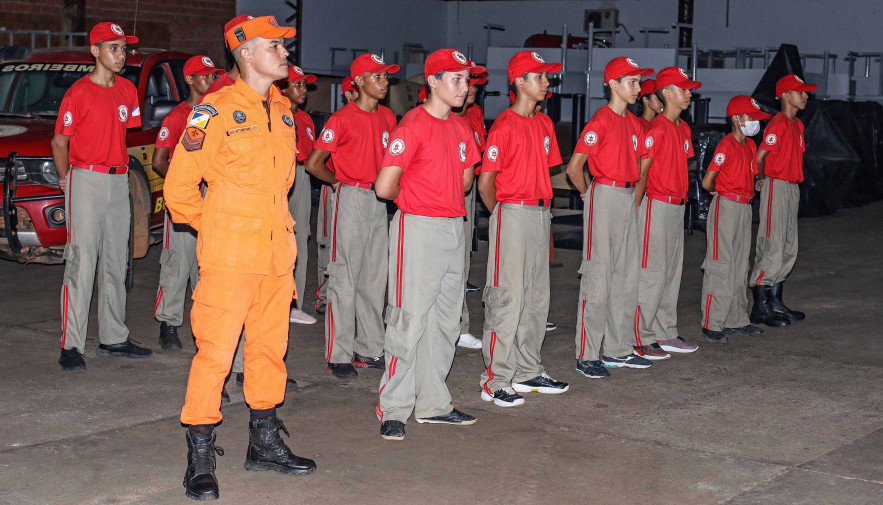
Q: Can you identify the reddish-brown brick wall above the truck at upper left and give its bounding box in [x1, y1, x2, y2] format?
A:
[0, 0, 236, 64]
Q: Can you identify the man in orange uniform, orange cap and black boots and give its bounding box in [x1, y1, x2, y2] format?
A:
[164, 16, 316, 500]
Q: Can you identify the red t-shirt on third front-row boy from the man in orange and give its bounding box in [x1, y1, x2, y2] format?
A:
[574, 105, 646, 182]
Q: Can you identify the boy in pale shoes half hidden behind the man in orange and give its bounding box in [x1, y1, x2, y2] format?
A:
[277, 65, 316, 324]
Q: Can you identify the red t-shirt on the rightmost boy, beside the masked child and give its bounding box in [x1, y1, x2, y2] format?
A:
[758, 112, 806, 182]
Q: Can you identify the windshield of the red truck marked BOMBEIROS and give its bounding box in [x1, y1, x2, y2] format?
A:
[0, 62, 140, 116]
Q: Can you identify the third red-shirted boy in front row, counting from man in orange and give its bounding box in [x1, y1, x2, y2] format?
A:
[567, 56, 667, 379]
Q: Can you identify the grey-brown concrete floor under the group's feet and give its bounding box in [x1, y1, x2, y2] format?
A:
[0, 203, 883, 505]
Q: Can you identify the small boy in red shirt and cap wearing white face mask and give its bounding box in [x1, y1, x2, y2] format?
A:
[701, 95, 787, 342]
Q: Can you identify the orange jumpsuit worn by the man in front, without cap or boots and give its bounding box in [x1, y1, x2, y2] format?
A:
[163, 79, 297, 425]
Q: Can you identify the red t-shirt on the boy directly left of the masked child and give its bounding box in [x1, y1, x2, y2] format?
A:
[641, 115, 693, 199]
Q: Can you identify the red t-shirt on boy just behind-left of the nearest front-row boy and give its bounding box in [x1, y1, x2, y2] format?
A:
[313, 103, 396, 184]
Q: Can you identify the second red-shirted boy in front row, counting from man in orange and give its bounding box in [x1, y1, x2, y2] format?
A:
[478, 51, 569, 407]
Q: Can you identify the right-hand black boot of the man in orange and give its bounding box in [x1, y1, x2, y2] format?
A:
[245, 417, 316, 475]
